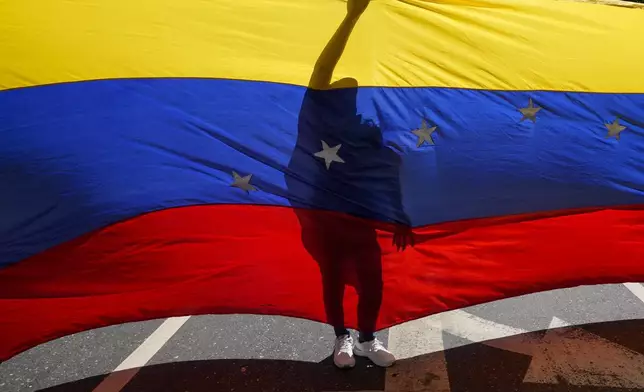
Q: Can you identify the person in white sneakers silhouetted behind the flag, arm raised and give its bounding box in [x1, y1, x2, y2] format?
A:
[286, 0, 408, 367]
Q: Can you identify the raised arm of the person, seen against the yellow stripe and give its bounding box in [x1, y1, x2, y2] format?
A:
[309, 0, 370, 90]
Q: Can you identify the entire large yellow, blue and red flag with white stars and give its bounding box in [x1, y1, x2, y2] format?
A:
[0, 0, 644, 359]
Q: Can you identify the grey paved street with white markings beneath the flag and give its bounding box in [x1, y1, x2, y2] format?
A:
[0, 284, 644, 392]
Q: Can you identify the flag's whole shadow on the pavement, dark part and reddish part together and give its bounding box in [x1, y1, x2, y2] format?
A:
[41, 320, 644, 392]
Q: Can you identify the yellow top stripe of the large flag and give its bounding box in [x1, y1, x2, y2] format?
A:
[0, 0, 644, 93]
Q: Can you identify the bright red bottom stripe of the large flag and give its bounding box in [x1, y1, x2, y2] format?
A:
[0, 205, 644, 359]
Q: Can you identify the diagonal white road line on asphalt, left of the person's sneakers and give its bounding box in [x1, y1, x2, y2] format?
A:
[94, 316, 190, 392]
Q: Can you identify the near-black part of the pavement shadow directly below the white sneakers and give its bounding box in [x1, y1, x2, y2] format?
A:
[41, 358, 385, 392]
